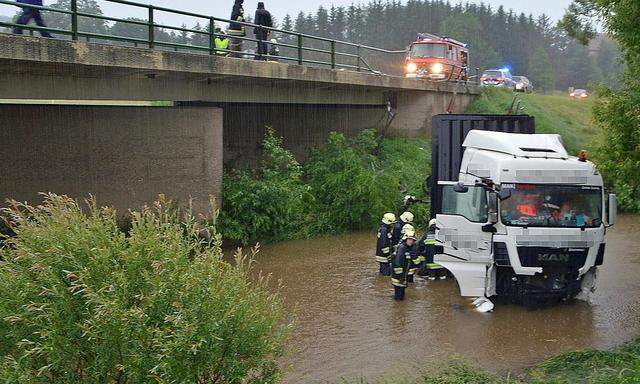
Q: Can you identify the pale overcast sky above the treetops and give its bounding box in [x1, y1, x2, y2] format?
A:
[0, 0, 571, 25]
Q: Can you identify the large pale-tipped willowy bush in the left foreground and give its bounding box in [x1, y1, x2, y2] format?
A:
[0, 195, 288, 383]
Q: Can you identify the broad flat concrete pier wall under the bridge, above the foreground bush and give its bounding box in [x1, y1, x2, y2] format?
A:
[0, 105, 223, 213]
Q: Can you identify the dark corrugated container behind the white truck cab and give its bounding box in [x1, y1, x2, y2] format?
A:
[430, 114, 535, 217]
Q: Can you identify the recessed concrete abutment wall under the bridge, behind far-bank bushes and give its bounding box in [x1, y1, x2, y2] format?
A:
[220, 91, 473, 167]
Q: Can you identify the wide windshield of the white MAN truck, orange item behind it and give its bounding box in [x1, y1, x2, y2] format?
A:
[500, 184, 602, 228]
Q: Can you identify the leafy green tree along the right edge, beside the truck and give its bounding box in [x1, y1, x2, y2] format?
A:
[562, 0, 640, 212]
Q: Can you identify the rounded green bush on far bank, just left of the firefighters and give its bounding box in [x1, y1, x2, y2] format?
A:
[304, 130, 399, 233]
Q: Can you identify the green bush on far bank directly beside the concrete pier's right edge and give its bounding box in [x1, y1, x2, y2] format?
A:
[220, 129, 311, 244]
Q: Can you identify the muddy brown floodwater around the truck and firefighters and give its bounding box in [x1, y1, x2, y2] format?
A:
[242, 216, 640, 383]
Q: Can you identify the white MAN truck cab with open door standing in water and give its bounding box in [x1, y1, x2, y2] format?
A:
[434, 130, 616, 306]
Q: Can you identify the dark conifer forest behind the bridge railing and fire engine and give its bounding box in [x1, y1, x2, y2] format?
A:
[0, 0, 622, 90]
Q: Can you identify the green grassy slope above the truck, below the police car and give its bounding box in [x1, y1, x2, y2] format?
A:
[466, 88, 598, 155]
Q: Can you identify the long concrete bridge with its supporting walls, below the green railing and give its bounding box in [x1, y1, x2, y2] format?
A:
[0, 34, 478, 214]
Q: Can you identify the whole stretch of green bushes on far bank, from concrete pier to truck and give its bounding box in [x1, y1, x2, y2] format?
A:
[220, 129, 431, 244]
